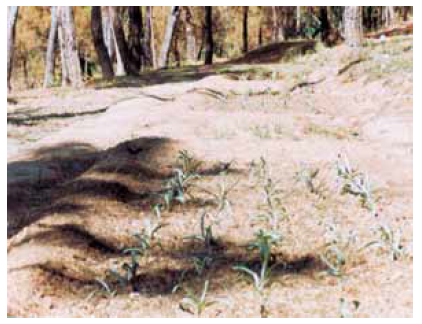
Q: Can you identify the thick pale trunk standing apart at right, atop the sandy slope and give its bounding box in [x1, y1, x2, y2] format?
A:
[344, 6, 363, 47]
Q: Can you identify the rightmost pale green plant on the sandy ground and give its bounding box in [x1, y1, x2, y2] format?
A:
[364, 225, 406, 261]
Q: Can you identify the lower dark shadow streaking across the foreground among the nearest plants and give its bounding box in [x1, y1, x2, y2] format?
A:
[10, 226, 325, 297]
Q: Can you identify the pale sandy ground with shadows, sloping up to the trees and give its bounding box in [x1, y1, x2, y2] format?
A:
[7, 36, 413, 317]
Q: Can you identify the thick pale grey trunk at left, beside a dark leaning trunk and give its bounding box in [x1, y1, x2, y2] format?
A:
[60, 6, 83, 88]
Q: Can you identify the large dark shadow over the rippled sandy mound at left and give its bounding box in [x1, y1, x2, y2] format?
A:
[7, 137, 234, 238]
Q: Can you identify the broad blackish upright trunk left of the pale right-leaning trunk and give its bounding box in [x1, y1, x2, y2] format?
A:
[128, 6, 144, 71]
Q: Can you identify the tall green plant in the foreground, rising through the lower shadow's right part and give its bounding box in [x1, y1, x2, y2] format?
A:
[233, 229, 282, 317]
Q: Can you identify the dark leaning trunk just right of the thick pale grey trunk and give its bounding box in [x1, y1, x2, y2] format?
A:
[91, 6, 114, 79]
